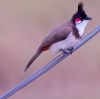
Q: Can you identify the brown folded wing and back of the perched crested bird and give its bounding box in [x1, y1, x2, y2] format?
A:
[39, 23, 73, 51]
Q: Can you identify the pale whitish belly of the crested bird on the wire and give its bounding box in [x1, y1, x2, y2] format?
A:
[50, 34, 79, 53]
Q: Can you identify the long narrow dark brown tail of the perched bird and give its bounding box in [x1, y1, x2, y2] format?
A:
[24, 49, 42, 71]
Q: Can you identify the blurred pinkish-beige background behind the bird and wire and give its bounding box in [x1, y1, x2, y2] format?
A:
[0, 0, 100, 99]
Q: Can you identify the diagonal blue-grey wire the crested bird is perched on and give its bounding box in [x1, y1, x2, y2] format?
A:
[0, 26, 100, 99]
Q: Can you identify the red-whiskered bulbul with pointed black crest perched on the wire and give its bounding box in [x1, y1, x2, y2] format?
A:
[25, 1, 92, 71]
